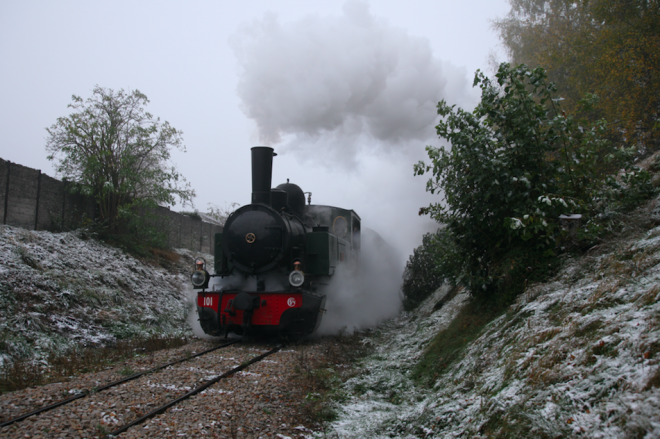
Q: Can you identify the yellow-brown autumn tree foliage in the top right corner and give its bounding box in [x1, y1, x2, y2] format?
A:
[495, 0, 660, 154]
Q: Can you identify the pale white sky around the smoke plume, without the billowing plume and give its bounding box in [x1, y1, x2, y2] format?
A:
[0, 0, 509, 262]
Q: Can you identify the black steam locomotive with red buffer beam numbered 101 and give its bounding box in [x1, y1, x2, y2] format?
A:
[191, 146, 361, 336]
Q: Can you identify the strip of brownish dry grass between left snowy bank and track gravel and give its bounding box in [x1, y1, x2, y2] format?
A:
[0, 337, 189, 393]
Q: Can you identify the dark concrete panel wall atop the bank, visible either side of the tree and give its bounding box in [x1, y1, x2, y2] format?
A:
[0, 158, 222, 253]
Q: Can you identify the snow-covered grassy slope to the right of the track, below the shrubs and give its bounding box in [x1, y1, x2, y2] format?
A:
[325, 210, 660, 438]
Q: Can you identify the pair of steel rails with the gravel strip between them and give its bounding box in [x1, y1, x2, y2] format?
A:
[0, 342, 292, 438]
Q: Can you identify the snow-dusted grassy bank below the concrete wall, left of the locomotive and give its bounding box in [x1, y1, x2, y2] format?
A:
[0, 226, 206, 362]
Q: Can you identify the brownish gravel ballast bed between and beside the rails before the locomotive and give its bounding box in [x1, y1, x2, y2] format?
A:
[0, 341, 340, 438]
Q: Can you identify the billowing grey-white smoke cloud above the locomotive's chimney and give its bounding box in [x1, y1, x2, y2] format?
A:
[232, 0, 473, 166]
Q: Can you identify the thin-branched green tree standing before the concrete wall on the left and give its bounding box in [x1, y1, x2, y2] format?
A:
[46, 86, 195, 228]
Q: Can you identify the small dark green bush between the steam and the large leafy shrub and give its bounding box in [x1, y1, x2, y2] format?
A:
[401, 229, 456, 311]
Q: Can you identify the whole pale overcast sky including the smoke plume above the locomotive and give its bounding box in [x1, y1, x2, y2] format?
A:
[0, 0, 509, 264]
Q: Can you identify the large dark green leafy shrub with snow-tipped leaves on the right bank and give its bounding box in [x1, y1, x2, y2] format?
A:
[415, 63, 650, 301]
